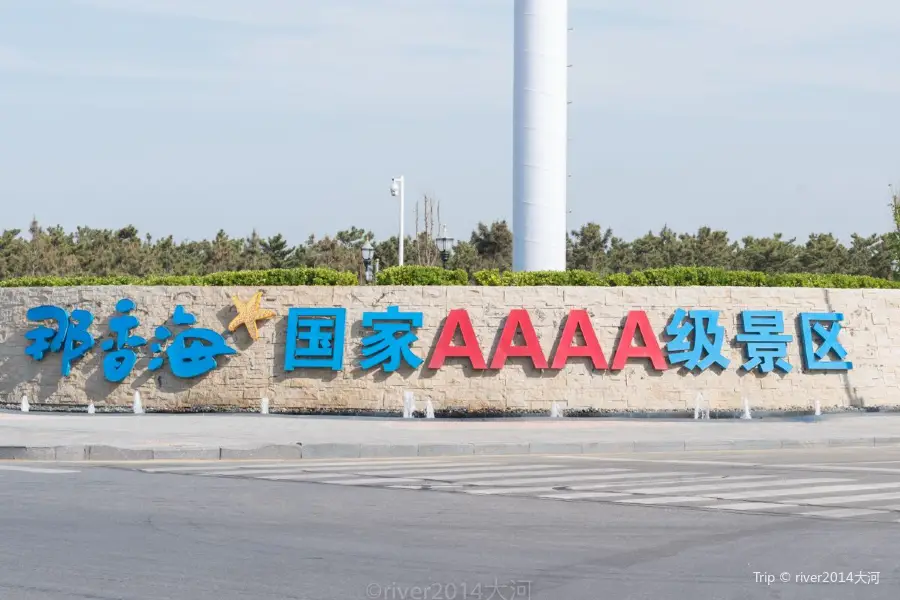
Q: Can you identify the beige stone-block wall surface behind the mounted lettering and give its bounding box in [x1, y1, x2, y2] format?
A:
[0, 287, 900, 411]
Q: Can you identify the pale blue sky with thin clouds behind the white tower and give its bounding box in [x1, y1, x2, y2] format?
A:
[0, 0, 900, 242]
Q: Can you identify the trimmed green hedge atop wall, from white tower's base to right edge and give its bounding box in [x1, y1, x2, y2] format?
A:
[473, 267, 900, 289]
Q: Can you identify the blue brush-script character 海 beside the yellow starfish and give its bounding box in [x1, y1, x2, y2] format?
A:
[149, 305, 237, 379]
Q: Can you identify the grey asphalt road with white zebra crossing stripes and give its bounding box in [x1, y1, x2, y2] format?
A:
[0, 448, 900, 600]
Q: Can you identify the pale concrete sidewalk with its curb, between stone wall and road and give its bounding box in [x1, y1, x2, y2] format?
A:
[0, 412, 900, 461]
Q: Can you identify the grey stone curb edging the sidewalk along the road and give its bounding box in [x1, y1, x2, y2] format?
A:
[0, 437, 900, 462]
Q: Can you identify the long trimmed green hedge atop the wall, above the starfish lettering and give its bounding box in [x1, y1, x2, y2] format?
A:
[0, 268, 359, 287]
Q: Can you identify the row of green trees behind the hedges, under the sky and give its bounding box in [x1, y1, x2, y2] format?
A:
[0, 193, 900, 279]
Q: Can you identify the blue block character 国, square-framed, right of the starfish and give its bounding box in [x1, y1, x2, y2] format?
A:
[284, 308, 347, 371]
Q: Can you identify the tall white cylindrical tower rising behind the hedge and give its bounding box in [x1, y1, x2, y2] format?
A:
[513, 0, 569, 271]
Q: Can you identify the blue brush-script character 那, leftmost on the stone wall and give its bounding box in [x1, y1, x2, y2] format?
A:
[25, 306, 94, 377]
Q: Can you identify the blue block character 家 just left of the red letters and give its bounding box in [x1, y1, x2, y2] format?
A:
[359, 306, 424, 373]
